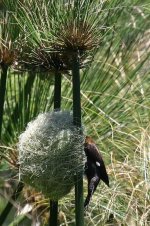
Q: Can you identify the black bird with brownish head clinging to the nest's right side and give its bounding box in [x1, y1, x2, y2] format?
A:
[84, 136, 109, 208]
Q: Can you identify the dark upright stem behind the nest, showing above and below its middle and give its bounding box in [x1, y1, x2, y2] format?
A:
[49, 71, 61, 226]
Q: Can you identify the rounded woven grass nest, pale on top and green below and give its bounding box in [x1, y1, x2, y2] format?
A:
[18, 111, 85, 200]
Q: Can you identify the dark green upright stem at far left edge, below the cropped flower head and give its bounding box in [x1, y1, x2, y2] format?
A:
[0, 65, 8, 138]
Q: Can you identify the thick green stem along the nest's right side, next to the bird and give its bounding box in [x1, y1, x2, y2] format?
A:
[72, 53, 84, 226]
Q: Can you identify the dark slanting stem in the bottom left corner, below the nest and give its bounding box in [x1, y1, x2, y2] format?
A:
[0, 181, 24, 225]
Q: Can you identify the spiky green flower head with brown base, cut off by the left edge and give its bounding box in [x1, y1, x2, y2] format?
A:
[0, 0, 19, 67]
